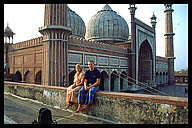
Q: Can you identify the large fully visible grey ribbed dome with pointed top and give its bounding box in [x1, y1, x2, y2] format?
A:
[85, 4, 129, 42]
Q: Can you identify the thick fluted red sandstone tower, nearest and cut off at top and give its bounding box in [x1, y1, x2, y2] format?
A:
[39, 4, 71, 86]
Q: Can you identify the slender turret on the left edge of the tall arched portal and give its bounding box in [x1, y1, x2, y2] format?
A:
[129, 4, 137, 84]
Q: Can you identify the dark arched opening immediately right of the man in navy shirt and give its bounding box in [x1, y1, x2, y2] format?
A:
[99, 70, 109, 91]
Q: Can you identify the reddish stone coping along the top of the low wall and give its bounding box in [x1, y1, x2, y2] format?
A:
[4, 81, 188, 107]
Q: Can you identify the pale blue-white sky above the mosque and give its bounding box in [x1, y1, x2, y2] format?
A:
[4, 4, 188, 71]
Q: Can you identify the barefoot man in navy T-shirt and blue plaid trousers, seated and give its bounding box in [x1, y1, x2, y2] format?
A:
[75, 60, 101, 113]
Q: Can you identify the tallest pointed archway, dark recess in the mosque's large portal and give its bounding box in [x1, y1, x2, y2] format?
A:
[138, 40, 153, 82]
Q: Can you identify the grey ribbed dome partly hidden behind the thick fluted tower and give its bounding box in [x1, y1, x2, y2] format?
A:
[67, 7, 86, 38]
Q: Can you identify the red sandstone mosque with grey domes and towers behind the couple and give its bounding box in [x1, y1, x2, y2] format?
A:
[4, 4, 175, 92]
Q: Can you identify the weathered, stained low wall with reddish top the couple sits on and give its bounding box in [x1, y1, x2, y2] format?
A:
[4, 81, 188, 124]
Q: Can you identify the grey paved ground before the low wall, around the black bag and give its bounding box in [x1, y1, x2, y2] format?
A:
[4, 92, 113, 124]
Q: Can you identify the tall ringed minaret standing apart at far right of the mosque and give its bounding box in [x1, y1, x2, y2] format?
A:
[164, 4, 175, 85]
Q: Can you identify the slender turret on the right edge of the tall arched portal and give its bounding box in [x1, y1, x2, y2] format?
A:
[150, 13, 157, 84]
